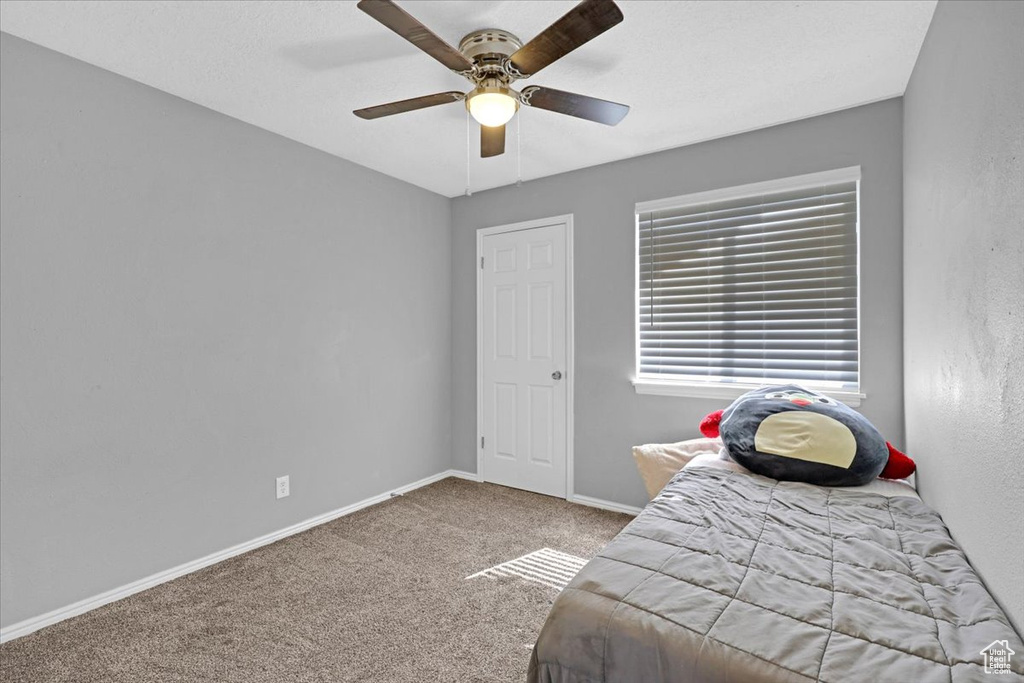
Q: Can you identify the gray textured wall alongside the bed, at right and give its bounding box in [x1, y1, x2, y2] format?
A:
[903, 2, 1024, 632]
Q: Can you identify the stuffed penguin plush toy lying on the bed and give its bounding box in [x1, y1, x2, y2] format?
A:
[700, 384, 915, 486]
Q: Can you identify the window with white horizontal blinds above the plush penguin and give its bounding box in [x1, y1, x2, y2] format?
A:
[634, 167, 862, 404]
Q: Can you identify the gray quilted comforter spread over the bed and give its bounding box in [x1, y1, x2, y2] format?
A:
[529, 467, 1024, 683]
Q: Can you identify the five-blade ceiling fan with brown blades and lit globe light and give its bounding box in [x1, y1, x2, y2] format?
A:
[353, 0, 630, 157]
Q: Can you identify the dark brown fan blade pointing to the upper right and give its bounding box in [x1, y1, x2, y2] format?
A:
[509, 0, 623, 77]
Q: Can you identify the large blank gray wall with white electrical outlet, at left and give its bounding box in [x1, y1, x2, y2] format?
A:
[0, 35, 452, 626]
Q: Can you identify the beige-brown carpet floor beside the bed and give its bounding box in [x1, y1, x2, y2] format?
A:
[0, 479, 629, 683]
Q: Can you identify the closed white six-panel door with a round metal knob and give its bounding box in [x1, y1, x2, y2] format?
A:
[478, 221, 568, 498]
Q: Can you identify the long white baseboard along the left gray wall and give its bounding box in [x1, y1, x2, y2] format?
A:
[0, 470, 468, 643]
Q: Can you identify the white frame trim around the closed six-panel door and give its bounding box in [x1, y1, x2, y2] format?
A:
[476, 213, 575, 501]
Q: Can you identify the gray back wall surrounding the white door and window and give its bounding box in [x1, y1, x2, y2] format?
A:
[453, 99, 903, 506]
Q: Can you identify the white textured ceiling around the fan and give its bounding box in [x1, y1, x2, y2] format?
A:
[0, 0, 935, 197]
